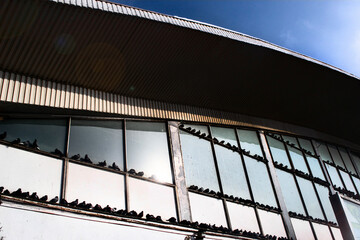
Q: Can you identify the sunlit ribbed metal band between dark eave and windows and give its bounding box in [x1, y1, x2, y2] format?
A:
[0, 68, 262, 126]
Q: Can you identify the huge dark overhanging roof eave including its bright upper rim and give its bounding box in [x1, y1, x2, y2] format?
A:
[0, 0, 360, 144]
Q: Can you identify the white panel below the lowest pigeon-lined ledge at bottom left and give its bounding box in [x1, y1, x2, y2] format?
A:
[0, 205, 186, 240]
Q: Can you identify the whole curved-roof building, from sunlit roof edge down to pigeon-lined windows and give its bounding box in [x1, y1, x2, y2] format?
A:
[0, 0, 360, 240]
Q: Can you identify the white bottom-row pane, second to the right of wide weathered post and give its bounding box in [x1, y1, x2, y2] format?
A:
[226, 202, 260, 232]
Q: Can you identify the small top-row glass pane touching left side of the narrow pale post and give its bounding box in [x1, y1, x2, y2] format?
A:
[237, 129, 263, 156]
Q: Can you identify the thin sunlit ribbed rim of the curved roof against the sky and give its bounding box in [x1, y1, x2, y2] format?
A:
[52, 0, 360, 80]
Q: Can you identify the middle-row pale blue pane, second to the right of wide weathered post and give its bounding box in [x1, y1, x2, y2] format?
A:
[215, 145, 250, 199]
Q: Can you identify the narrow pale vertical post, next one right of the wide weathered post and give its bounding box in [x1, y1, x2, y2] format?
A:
[259, 130, 296, 239]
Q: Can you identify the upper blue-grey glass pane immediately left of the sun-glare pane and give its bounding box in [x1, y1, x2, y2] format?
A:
[69, 119, 124, 169]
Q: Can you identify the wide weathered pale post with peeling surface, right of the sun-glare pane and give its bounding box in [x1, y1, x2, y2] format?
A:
[168, 121, 192, 221]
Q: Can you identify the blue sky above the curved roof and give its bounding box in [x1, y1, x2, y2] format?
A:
[112, 0, 360, 77]
